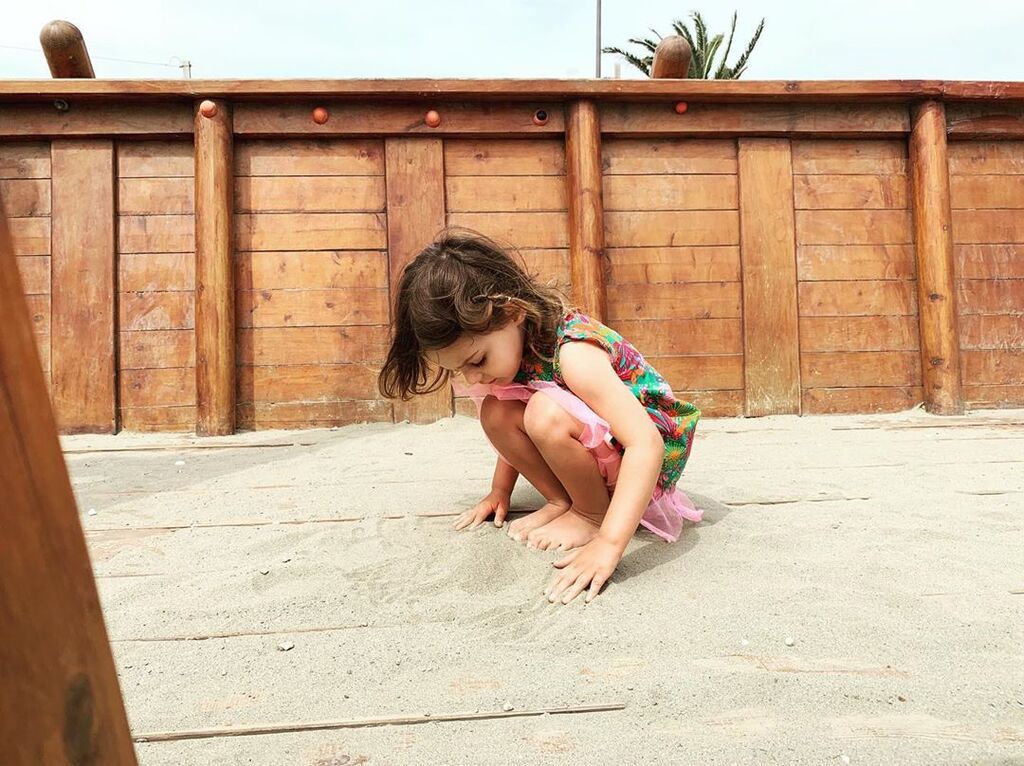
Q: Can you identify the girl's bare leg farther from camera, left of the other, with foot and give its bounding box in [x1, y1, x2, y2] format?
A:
[480, 396, 572, 542]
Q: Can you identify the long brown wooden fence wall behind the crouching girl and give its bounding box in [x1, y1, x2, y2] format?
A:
[0, 80, 1024, 434]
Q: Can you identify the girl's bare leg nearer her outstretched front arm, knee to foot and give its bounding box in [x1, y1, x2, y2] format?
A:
[523, 392, 610, 550]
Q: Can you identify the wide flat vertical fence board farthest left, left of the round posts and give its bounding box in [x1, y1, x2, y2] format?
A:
[50, 138, 117, 433]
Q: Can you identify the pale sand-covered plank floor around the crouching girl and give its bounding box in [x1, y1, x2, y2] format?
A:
[65, 412, 1024, 766]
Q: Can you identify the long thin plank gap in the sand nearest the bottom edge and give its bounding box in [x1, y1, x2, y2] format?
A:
[132, 703, 626, 742]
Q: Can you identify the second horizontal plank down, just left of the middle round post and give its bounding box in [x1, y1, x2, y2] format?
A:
[444, 175, 567, 213]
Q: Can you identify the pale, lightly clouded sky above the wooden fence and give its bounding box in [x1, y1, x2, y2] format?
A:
[0, 0, 1024, 80]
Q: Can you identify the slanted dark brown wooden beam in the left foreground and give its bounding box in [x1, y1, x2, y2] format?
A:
[0, 201, 135, 766]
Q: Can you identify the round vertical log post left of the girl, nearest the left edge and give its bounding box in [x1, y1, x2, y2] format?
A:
[196, 101, 236, 436]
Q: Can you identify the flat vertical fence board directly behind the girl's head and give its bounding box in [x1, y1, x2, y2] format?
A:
[384, 137, 453, 423]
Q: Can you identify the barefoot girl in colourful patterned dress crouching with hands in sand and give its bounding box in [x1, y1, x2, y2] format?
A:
[379, 232, 701, 603]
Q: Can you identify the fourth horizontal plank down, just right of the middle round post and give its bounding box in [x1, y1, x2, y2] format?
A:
[606, 246, 740, 285]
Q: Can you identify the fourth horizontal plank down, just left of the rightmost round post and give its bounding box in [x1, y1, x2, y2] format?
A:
[797, 245, 918, 282]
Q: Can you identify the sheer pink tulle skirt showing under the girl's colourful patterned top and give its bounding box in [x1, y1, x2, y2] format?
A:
[453, 380, 703, 543]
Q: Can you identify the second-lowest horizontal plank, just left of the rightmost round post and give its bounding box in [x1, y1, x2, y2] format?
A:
[800, 351, 921, 388]
